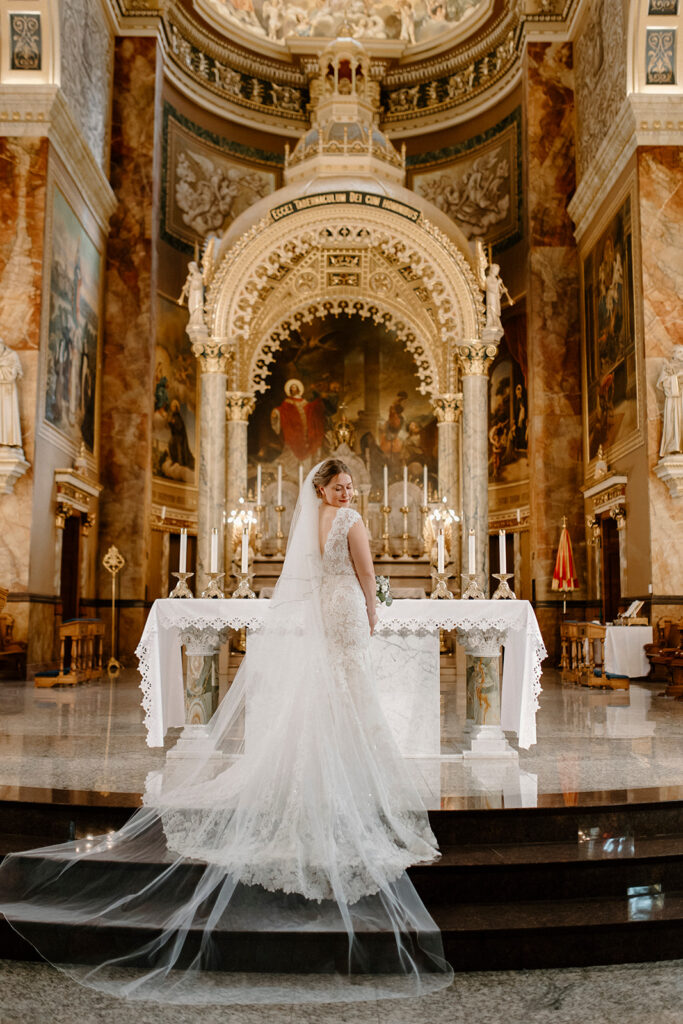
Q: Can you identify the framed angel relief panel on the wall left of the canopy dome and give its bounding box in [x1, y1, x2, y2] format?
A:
[162, 104, 280, 250]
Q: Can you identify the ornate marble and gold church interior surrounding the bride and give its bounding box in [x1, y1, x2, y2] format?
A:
[0, 0, 683, 1024]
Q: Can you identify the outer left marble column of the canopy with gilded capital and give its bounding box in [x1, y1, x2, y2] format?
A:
[187, 325, 232, 594]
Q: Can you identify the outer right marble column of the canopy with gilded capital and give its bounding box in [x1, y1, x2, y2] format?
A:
[456, 342, 502, 594]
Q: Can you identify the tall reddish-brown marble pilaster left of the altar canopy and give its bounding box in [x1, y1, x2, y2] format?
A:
[99, 38, 157, 657]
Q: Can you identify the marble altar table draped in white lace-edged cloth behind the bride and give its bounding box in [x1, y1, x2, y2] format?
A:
[136, 598, 546, 757]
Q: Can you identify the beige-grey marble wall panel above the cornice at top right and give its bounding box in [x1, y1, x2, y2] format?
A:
[574, 0, 627, 179]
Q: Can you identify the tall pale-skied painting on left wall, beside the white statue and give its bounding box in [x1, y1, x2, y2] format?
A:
[45, 186, 101, 452]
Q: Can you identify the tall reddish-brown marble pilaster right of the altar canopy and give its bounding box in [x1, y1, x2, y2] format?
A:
[523, 42, 586, 659]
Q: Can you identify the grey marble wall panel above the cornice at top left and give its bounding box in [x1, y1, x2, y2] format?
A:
[59, 0, 114, 167]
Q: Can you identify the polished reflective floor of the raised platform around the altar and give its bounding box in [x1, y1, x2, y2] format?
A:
[0, 670, 683, 809]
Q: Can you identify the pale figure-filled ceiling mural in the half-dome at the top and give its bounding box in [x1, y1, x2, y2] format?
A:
[201, 0, 487, 45]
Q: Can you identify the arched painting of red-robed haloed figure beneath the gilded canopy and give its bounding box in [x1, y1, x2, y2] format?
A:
[249, 317, 437, 492]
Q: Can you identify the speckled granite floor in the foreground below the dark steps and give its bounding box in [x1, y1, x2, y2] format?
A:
[0, 961, 683, 1024]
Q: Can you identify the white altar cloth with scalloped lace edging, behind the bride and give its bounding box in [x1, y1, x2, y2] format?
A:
[136, 598, 546, 750]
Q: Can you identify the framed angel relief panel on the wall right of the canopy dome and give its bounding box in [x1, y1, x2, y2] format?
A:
[411, 114, 520, 245]
